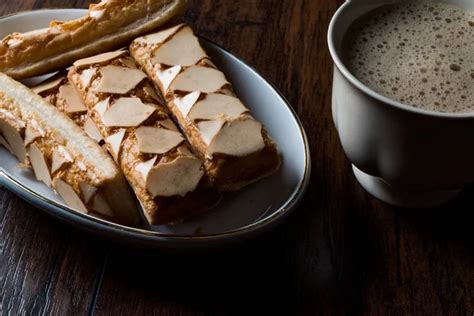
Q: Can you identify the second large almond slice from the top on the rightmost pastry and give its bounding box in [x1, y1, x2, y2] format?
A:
[170, 66, 229, 93]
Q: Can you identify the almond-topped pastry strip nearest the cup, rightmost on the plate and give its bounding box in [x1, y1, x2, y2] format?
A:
[130, 24, 280, 191]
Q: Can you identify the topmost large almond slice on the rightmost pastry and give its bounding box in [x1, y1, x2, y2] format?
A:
[152, 26, 207, 67]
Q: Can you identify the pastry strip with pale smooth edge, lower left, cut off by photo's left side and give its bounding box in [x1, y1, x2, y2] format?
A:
[0, 73, 138, 225]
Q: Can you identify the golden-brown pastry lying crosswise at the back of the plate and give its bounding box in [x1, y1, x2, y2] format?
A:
[0, 0, 186, 79]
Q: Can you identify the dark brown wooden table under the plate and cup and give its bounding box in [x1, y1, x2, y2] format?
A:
[0, 0, 474, 315]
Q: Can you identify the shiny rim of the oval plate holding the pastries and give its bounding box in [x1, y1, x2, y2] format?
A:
[0, 8, 311, 242]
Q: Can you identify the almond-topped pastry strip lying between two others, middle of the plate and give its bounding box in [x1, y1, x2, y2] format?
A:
[68, 51, 220, 225]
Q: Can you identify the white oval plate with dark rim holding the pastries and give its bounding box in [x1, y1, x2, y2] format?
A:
[0, 9, 311, 248]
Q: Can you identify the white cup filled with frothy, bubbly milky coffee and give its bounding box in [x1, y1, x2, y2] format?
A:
[328, 0, 474, 207]
